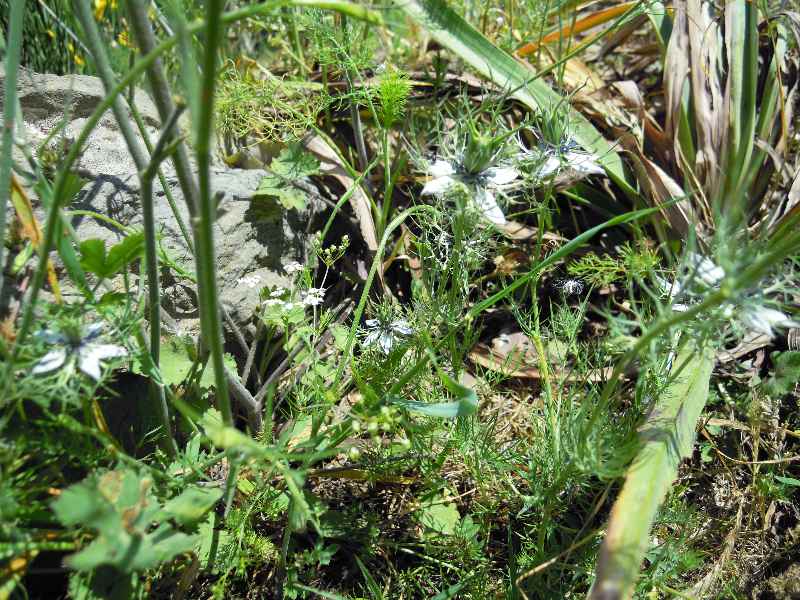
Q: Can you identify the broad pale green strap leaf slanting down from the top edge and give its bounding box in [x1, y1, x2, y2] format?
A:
[395, 0, 636, 195]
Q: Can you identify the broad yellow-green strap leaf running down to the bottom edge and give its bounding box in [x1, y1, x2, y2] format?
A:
[589, 343, 714, 600]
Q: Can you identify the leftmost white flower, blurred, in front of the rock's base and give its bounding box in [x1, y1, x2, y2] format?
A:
[31, 323, 128, 381]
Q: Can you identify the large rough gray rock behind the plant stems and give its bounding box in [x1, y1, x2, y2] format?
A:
[0, 71, 313, 333]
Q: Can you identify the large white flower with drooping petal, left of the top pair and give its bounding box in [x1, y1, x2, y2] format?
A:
[422, 159, 519, 225]
